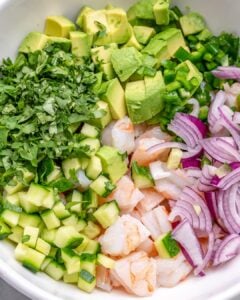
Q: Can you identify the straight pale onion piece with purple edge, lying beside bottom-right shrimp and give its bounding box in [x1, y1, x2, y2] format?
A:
[172, 220, 203, 267]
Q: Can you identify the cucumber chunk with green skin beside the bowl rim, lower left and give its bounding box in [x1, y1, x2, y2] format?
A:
[15, 243, 45, 272]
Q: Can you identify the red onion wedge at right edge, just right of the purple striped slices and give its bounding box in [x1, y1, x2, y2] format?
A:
[199, 137, 240, 163]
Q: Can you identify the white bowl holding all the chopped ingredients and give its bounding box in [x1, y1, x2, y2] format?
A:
[0, 0, 240, 300]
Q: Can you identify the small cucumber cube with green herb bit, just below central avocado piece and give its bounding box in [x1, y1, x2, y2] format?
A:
[90, 175, 116, 197]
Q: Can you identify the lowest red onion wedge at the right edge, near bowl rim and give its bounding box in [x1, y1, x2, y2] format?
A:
[213, 234, 240, 266]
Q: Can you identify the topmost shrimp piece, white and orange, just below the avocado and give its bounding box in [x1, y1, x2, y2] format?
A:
[102, 117, 135, 154]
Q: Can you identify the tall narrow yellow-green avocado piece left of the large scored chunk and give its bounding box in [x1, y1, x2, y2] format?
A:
[101, 78, 127, 120]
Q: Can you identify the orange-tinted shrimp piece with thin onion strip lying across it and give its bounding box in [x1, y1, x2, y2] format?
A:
[132, 137, 170, 166]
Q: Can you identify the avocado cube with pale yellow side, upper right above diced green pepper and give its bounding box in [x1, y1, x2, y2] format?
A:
[153, 28, 188, 57]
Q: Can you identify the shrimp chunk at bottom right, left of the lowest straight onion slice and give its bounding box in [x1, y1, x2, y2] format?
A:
[156, 253, 192, 287]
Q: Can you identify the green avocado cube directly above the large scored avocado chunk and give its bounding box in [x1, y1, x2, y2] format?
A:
[111, 47, 142, 82]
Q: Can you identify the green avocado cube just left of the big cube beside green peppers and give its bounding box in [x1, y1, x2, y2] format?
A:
[142, 37, 171, 67]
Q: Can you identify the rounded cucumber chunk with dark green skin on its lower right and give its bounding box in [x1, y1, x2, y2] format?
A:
[54, 226, 84, 248]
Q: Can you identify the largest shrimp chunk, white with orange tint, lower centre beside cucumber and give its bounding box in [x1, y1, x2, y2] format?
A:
[99, 215, 150, 256]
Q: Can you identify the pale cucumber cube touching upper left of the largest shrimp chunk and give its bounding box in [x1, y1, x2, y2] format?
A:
[93, 200, 120, 229]
